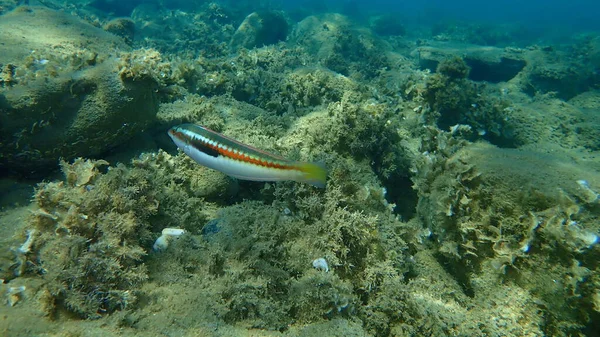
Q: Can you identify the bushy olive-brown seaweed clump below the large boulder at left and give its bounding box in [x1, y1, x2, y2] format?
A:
[29, 159, 158, 318]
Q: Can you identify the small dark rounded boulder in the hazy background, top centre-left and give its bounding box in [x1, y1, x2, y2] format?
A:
[231, 11, 288, 50]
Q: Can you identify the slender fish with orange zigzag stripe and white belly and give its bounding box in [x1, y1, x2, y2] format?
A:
[168, 124, 327, 188]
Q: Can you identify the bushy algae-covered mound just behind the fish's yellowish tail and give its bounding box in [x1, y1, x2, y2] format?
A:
[281, 91, 416, 214]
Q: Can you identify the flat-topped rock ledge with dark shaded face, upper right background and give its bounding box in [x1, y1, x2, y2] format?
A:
[416, 43, 527, 83]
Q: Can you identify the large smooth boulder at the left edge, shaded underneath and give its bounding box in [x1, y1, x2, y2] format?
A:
[0, 7, 158, 174]
